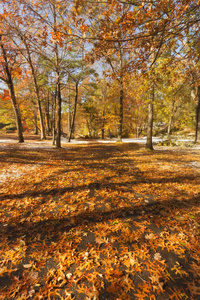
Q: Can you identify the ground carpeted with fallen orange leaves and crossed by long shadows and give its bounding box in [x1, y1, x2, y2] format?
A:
[0, 134, 200, 300]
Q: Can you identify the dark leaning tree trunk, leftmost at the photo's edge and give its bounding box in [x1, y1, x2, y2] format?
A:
[0, 35, 24, 143]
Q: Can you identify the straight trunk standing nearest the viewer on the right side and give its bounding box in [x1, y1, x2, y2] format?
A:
[146, 85, 154, 150]
